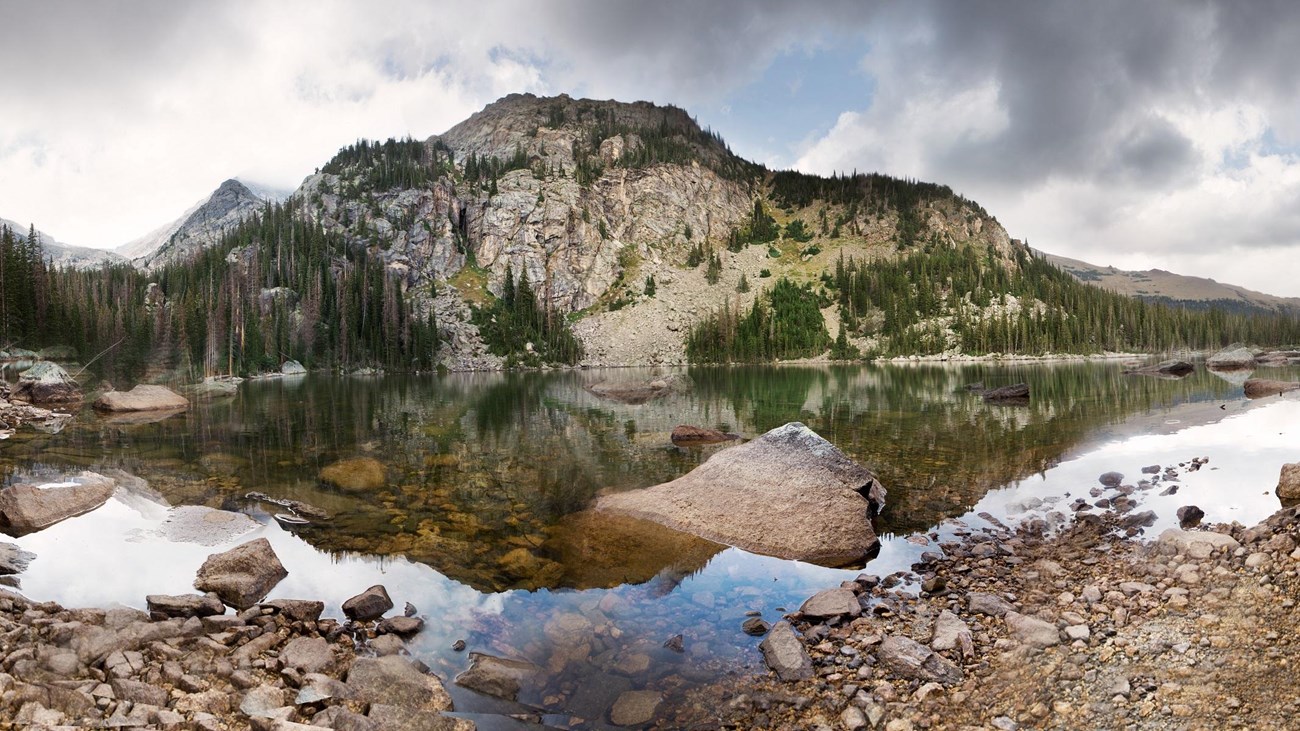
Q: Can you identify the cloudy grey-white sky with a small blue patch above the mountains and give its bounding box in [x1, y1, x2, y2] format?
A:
[0, 0, 1300, 297]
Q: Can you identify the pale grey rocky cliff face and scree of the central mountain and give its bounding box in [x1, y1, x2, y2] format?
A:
[296, 95, 1010, 368]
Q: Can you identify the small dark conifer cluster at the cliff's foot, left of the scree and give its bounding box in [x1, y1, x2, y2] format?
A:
[473, 268, 582, 367]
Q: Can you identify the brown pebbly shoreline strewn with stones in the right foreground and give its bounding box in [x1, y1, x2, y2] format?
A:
[659, 460, 1300, 731]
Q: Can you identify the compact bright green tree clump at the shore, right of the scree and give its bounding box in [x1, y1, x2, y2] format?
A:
[686, 277, 831, 363]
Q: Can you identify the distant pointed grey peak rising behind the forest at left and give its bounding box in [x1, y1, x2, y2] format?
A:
[114, 178, 276, 271]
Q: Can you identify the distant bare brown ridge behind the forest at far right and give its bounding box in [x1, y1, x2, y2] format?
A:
[1044, 254, 1300, 313]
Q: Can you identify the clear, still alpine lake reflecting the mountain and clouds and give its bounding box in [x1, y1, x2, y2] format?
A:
[0, 360, 1300, 728]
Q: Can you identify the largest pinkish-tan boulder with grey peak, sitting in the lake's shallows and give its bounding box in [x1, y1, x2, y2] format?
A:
[595, 423, 885, 565]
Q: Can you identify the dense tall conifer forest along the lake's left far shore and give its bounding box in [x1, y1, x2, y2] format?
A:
[19, 204, 438, 382]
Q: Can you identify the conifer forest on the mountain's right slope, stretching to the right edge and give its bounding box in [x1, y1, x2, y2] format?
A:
[833, 246, 1300, 355]
